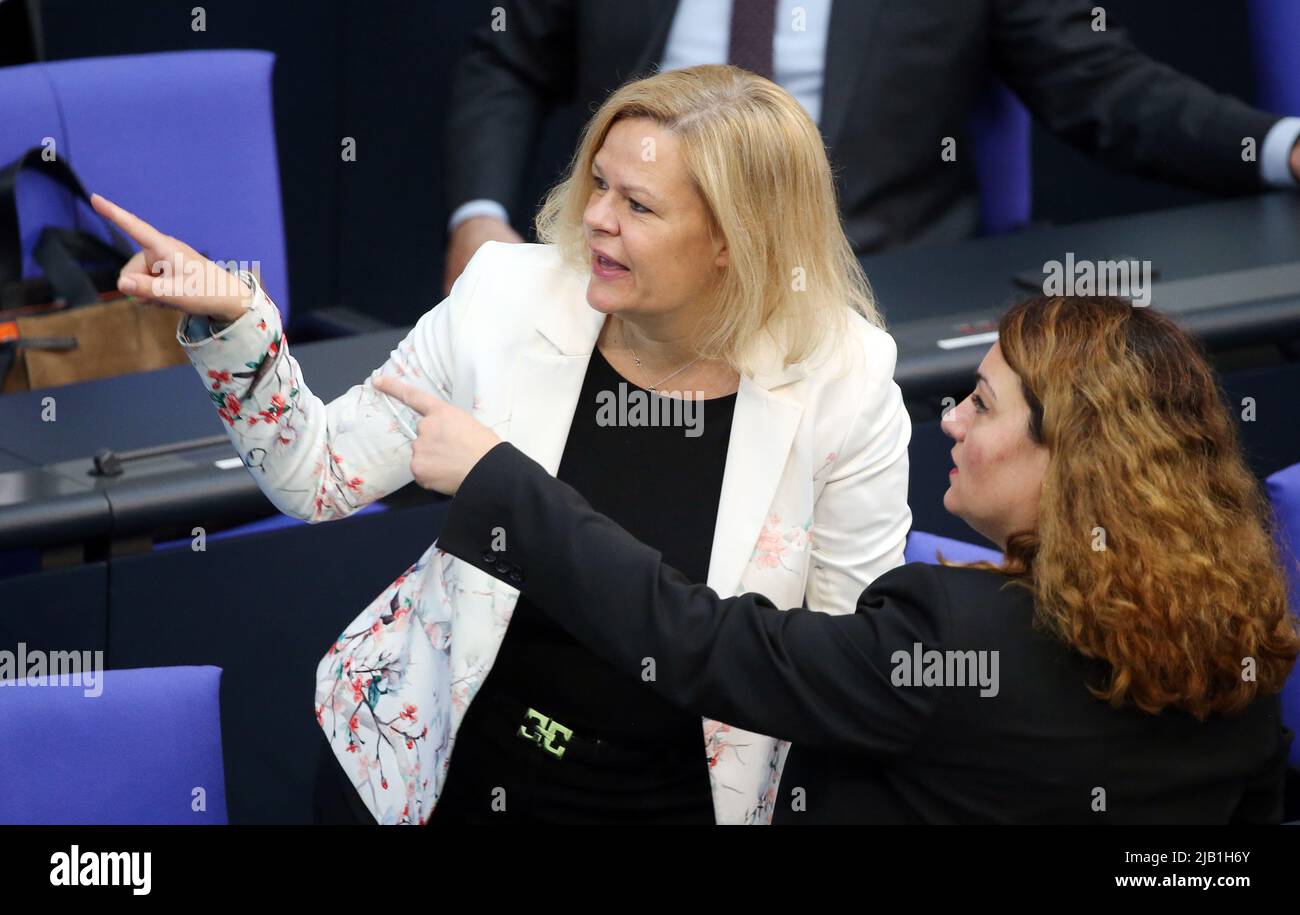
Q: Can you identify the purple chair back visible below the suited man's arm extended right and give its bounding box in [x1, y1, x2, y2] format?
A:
[971, 79, 1032, 235]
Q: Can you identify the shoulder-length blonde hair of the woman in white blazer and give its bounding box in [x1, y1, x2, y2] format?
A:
[536, 64, 884, 372]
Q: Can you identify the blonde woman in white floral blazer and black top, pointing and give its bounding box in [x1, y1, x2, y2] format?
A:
[96, 60, 911, 824]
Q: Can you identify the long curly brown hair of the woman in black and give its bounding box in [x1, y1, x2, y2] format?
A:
[956, 296, 1300, 719]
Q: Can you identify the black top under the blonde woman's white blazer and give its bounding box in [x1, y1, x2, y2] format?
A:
[476, 348, 736, 760]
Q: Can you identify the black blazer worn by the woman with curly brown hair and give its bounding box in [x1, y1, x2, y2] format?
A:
[438, 443, 1291, 823]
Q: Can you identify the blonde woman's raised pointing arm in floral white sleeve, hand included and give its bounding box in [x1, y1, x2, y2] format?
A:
[94, 195, 497, 522]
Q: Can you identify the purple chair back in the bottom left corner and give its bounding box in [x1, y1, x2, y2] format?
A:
[0, 662, 226, 825]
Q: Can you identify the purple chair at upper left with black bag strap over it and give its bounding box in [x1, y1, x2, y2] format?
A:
[0, 51, 289, 326]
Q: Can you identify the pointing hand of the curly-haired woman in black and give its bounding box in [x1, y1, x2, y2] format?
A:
[371, 376, 502, 495]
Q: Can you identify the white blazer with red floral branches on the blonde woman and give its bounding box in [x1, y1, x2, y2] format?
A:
[177, 242, 911, 824]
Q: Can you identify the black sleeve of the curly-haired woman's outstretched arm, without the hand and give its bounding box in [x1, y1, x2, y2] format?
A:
[438, 443, 948, 755]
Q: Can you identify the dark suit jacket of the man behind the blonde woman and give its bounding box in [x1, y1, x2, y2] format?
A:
[443, 0, 1278, 253]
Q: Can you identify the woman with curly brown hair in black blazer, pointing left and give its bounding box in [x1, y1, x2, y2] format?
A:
[374, 298, 1300, 823]
